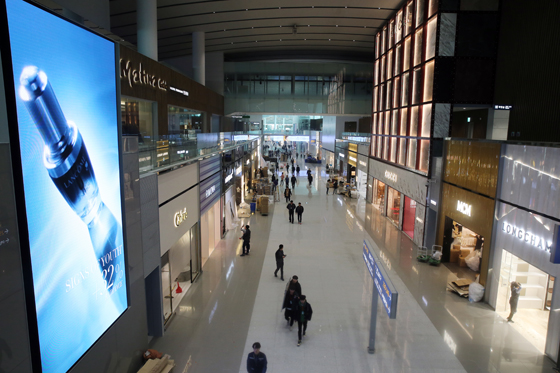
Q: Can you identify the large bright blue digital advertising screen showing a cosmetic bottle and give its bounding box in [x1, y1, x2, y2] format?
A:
[5, 0, 128, 373]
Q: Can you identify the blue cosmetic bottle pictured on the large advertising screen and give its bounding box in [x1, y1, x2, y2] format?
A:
[19, 66, 124, 300]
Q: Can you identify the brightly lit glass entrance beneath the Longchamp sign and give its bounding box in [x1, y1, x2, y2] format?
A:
[496, 250, 554, 353]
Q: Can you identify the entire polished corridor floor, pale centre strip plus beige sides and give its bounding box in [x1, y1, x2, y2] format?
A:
[151, 161, 553, 373]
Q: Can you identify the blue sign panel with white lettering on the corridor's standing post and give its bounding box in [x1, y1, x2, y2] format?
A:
[363, 240, 399, 319]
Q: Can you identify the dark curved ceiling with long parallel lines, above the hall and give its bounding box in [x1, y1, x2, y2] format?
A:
[110, 0, 403, 62]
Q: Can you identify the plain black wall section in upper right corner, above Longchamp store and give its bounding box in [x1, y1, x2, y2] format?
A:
[494, 0, 560, 142]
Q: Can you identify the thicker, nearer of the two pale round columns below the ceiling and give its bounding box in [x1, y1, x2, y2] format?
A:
[136, 0, 158, 61]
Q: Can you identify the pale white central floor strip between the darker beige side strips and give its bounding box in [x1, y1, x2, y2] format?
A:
[239, 167, 465, 373]
